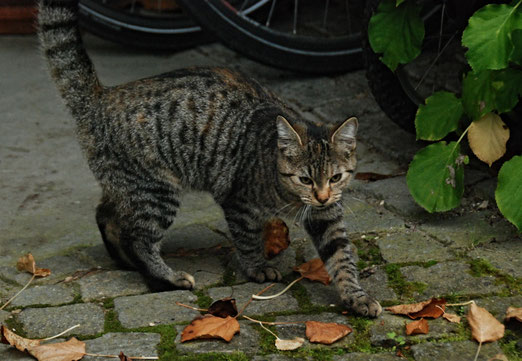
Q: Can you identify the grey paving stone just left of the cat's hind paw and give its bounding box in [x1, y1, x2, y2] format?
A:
[77, 271, 149, 301]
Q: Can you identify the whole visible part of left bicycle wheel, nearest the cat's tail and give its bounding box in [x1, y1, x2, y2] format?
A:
[79, 0, 213, 50]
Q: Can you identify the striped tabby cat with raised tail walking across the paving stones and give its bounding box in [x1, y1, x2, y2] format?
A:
[38, 0, 381, 317]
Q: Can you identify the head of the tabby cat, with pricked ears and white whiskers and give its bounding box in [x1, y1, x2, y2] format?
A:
[277, 116, 358, 208]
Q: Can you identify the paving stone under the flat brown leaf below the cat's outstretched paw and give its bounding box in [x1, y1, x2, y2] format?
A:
[274, 312, 355, 349]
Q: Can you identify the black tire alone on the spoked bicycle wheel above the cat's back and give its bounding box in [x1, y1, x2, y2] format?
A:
[175, 0, 363, 74]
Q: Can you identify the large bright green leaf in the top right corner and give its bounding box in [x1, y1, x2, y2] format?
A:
[462, 1, 522, 71]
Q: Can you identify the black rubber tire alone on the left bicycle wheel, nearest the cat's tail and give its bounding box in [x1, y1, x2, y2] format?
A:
[79, 0, 214, 50]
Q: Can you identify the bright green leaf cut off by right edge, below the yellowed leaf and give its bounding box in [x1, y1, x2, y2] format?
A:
[495, 155, 522, 231]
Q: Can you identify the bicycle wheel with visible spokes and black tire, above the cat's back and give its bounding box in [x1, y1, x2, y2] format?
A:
[179, 0, 363, 73]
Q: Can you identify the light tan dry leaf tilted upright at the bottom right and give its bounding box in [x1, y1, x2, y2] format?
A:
[467, 303, 504, 343]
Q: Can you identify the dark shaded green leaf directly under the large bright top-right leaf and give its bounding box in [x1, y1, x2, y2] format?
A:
[462, 68, 522, 120]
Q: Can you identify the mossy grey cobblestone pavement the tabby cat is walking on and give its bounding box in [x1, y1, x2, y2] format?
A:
[0, 36, 522, 361]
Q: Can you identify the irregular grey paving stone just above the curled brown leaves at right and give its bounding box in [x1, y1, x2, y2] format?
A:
[401, 262, 502, 299]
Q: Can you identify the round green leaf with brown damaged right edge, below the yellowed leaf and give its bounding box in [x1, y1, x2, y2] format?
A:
[406, 142, 468, 213]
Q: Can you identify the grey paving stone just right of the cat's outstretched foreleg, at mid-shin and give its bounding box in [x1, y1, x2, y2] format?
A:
[377, 231, 455, 263]
